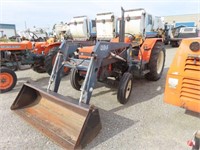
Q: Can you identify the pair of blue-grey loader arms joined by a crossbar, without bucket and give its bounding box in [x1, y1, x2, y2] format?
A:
[47, 42, 131, 104]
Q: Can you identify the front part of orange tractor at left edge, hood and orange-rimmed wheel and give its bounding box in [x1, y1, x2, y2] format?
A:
[0, 41, 45, 93]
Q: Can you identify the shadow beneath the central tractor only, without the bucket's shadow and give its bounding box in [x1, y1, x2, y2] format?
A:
[92, 68, 168, 112]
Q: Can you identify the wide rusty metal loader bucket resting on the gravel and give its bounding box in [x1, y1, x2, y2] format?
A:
[11, 83, 101, 149]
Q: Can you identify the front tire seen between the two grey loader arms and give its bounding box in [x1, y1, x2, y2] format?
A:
[70, 69, 84, 91]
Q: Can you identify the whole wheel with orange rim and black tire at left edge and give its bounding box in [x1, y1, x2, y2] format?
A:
[0, 67, 17, 93]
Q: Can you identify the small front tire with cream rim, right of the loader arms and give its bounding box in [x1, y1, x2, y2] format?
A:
[117, 72, 133, 104]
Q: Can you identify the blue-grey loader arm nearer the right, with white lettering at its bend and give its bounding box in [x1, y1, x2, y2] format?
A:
[76, 42, 131, 104]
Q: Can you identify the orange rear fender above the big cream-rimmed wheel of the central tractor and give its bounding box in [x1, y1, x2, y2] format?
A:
[138, 38, 162, 62]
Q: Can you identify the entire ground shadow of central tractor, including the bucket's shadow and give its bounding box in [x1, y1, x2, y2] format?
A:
[86, 68, 168, 149]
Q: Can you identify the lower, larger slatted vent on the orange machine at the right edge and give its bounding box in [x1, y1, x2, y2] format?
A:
[180, 78, 200, 101]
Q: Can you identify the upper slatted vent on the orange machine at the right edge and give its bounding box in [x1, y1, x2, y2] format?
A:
[185, 59, 200, 74]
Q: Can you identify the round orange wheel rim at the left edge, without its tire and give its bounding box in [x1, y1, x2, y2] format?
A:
[0, 73, 13, 90]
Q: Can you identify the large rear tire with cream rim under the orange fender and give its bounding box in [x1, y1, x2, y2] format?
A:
[145, 42, 165, 81]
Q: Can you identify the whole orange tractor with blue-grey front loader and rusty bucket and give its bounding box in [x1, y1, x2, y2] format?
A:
[11, 9, 165, 149]
